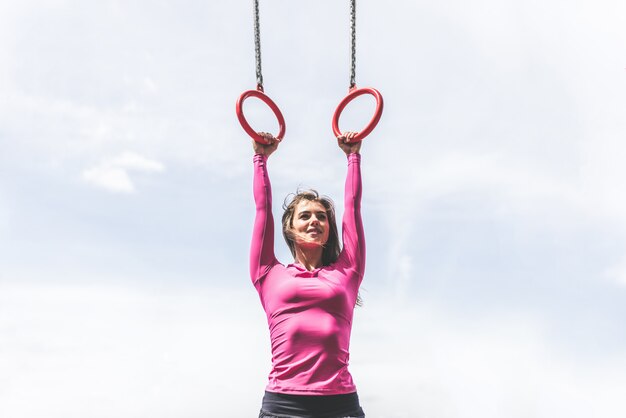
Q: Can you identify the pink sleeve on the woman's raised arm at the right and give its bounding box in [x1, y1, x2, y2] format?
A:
[340, 154, 365, 277]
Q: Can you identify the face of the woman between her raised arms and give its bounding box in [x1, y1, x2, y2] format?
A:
[293, 200, 329, 246]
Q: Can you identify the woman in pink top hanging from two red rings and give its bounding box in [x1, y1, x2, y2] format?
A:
[250, 132, 365, 418]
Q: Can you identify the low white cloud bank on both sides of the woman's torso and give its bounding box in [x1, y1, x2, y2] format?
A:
[0, 283, 626, 418]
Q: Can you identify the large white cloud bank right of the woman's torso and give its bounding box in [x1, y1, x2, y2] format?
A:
[352, 295, 626, 418]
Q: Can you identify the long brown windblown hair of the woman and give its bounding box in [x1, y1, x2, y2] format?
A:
[283, 189, 341, 266]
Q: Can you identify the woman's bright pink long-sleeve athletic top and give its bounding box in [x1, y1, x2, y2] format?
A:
[250, 154, 365, 395]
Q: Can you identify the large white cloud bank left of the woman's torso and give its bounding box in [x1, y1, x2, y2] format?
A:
[0, 284, 269, 418]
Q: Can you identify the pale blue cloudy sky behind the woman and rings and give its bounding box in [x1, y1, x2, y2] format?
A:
[0, 0, 626, 418]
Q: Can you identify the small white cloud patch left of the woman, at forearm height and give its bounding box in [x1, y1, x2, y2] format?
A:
[82, 152, 165, 193]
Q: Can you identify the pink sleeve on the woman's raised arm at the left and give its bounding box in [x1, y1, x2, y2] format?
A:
[250, 154, 276, 283]
